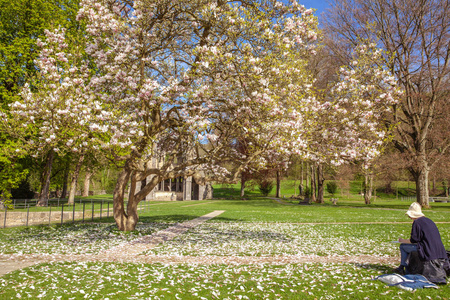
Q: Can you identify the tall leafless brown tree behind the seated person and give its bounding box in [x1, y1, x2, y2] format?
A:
[324, 0, 450, 206]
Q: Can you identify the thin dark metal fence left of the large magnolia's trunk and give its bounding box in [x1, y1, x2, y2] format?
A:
[0, 199, 149, 228]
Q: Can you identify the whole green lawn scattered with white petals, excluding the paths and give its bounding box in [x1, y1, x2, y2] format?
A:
[0, 191, 450, 299]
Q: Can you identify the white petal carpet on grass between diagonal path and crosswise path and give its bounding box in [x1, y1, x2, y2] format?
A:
[146, 222, 398, 258]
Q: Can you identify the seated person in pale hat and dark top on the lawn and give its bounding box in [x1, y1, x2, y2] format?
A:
[394, 202, 448, 277]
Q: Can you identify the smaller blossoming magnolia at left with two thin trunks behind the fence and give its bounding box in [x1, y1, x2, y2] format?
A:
[8, 29, 100, 205]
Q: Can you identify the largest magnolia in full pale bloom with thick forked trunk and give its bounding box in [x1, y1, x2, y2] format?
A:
[5, 0, 400, 230]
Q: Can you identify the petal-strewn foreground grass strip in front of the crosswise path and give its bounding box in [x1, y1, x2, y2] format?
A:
[0, 262, 448, 300]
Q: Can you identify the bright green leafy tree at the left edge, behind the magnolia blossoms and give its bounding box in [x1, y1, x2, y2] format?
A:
[0, 0, 80, 205]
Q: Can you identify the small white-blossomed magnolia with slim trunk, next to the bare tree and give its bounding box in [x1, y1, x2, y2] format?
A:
[309, 41, 402, 204]
